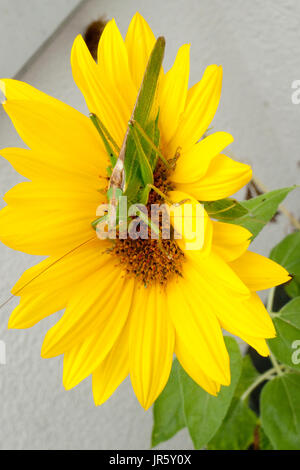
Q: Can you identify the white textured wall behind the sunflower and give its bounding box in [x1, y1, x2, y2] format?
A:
[0, 0, 300, 449]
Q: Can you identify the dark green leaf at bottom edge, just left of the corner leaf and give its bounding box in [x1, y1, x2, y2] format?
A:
[207, 397, 257, 450]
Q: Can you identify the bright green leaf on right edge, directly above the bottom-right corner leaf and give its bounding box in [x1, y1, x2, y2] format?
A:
[268, 297, 300, 370]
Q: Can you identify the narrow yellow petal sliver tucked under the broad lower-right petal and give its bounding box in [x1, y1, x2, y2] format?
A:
[175, 335, 221, 396]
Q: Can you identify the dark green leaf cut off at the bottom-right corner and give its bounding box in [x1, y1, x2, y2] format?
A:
[260, 373, 300, 450]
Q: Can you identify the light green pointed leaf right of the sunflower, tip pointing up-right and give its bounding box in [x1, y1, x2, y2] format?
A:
[231, 186, 296, 239]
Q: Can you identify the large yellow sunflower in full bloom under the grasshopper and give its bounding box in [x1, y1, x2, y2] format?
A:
[0, 13, 289, 409]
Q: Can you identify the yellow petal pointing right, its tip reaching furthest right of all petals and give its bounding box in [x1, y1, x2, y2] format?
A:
[230, 251, 291, 291]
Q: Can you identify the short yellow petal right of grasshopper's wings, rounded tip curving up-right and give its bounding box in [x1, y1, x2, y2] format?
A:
[170, 132, 233, 183]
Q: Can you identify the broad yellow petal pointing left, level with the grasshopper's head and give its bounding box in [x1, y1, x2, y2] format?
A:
[0, 182, 104, 255]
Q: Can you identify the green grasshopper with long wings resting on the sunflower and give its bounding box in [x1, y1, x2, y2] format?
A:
[90, 37, 171, 239]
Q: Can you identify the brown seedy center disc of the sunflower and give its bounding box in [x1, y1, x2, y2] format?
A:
[111, 163, 184, 286]
